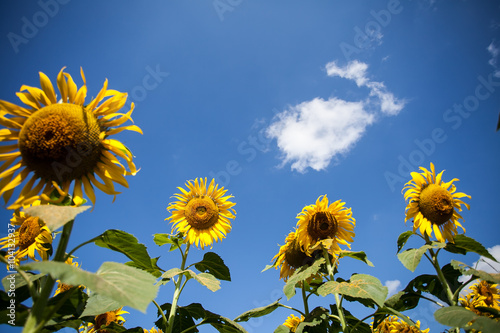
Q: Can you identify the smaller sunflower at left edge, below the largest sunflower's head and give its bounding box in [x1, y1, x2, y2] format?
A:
[0, 201, 53, 265]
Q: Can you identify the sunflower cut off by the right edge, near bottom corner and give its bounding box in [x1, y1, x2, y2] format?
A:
[459, 280, 500, 317]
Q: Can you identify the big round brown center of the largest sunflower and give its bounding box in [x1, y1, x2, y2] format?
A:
[19, 103, 102, 183]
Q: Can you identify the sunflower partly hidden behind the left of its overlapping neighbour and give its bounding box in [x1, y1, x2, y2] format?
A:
[273, 231, 313, 282]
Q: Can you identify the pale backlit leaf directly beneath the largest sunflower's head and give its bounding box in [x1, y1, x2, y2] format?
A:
[23, 205, 90, 231]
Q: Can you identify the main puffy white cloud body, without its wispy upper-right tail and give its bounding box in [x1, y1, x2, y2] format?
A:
[267, 98, 374, 172]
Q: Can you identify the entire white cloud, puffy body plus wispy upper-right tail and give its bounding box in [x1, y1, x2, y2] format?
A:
[266, 61, 406, 172]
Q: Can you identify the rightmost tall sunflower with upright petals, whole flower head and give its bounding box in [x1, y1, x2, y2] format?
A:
[403, 163, 470, 243]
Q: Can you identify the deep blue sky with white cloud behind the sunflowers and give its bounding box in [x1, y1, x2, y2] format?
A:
[0, 0, 500, 332]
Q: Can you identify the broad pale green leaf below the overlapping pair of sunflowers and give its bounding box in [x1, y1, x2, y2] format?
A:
[318, 274, 389, 307]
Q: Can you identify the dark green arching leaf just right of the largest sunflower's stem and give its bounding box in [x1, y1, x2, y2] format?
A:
[94, 229, 161, 277]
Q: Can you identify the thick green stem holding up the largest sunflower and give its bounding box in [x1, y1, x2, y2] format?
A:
[23, 220, 74, 333]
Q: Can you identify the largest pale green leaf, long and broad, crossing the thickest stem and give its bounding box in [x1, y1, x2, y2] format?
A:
[21, 261, 158, 312]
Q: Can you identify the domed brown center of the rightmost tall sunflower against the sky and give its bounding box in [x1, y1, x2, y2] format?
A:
[418, 184, 453, 225]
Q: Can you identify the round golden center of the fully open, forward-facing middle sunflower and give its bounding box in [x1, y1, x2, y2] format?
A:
[184, 195, 219, 229]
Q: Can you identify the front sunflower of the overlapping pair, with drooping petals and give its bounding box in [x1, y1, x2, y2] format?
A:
[297, 195, 356, 257]
